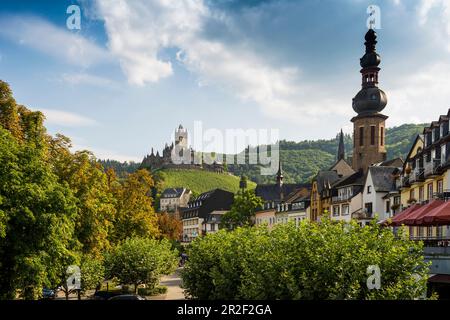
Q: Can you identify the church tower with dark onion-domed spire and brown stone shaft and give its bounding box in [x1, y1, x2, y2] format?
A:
[352, 29, 388, 172]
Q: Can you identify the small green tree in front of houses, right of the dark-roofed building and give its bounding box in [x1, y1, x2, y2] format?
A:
[221, 189, 263, 230]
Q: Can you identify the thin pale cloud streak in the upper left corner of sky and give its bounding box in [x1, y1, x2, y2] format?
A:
[0, 15, 110, 67]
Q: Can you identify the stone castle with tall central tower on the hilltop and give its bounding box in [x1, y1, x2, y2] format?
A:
[141, 124, 224, 173]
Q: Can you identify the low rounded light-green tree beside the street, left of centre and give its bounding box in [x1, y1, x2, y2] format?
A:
[105, 238, 177, 293]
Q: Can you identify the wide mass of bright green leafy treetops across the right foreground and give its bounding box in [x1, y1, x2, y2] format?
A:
[182, 219, 429, 300]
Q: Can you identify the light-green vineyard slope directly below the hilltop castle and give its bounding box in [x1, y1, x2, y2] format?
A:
[155, 169, 256, 195]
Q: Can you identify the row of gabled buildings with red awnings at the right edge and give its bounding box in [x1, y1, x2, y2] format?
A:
[393, 109, 450, 240]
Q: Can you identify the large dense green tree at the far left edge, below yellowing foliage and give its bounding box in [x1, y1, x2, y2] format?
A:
[0, 126, 77, 299]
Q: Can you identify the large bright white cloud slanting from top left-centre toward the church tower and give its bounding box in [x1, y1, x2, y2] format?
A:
[96, 0, 348, 123]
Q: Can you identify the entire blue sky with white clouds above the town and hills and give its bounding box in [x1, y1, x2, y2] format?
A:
[0, 0, 450, 161]
